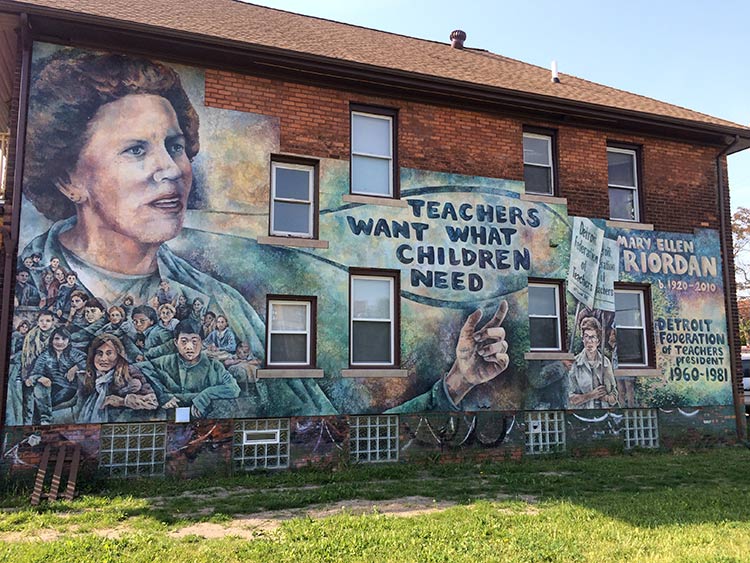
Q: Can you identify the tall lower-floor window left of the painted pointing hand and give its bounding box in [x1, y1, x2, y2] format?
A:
[350, 273, 399, 366]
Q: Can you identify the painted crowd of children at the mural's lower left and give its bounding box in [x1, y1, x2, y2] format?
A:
[7, 256, 259, 425]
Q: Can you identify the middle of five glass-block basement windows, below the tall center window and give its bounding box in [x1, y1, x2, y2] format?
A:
[349, 415, 398, 463]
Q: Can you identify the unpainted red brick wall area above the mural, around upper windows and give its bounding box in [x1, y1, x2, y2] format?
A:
[206, 70, 719, 232]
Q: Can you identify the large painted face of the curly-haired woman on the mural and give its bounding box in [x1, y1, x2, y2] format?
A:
[68, 94, 193, 244]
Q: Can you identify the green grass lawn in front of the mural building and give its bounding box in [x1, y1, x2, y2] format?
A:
[0, 447, 750, 563]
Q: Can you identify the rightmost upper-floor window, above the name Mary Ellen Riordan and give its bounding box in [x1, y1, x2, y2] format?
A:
[607, 147, 640, 221]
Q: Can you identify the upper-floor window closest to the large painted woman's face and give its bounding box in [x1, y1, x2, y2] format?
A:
[271, 161, 316, 238]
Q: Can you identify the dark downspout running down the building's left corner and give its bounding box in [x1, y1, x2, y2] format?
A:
[0, 14, 32, 443]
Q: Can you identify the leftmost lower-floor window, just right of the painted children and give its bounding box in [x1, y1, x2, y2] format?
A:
[266, 299, 313, 367]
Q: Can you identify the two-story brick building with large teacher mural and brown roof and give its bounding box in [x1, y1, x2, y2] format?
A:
[0, 0, 750, 475]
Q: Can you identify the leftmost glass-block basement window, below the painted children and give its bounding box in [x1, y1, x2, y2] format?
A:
[99, 422, 167, 477]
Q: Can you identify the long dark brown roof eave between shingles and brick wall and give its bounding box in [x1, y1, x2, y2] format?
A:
[5, 0, 750, 154]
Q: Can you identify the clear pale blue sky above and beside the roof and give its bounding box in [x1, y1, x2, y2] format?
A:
[244, 0, 750, 209]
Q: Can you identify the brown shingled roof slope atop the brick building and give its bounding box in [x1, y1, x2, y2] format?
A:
[2, 0, 750, 137]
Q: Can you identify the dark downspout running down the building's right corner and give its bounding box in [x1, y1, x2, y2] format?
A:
[716, 135, 747, 441]
